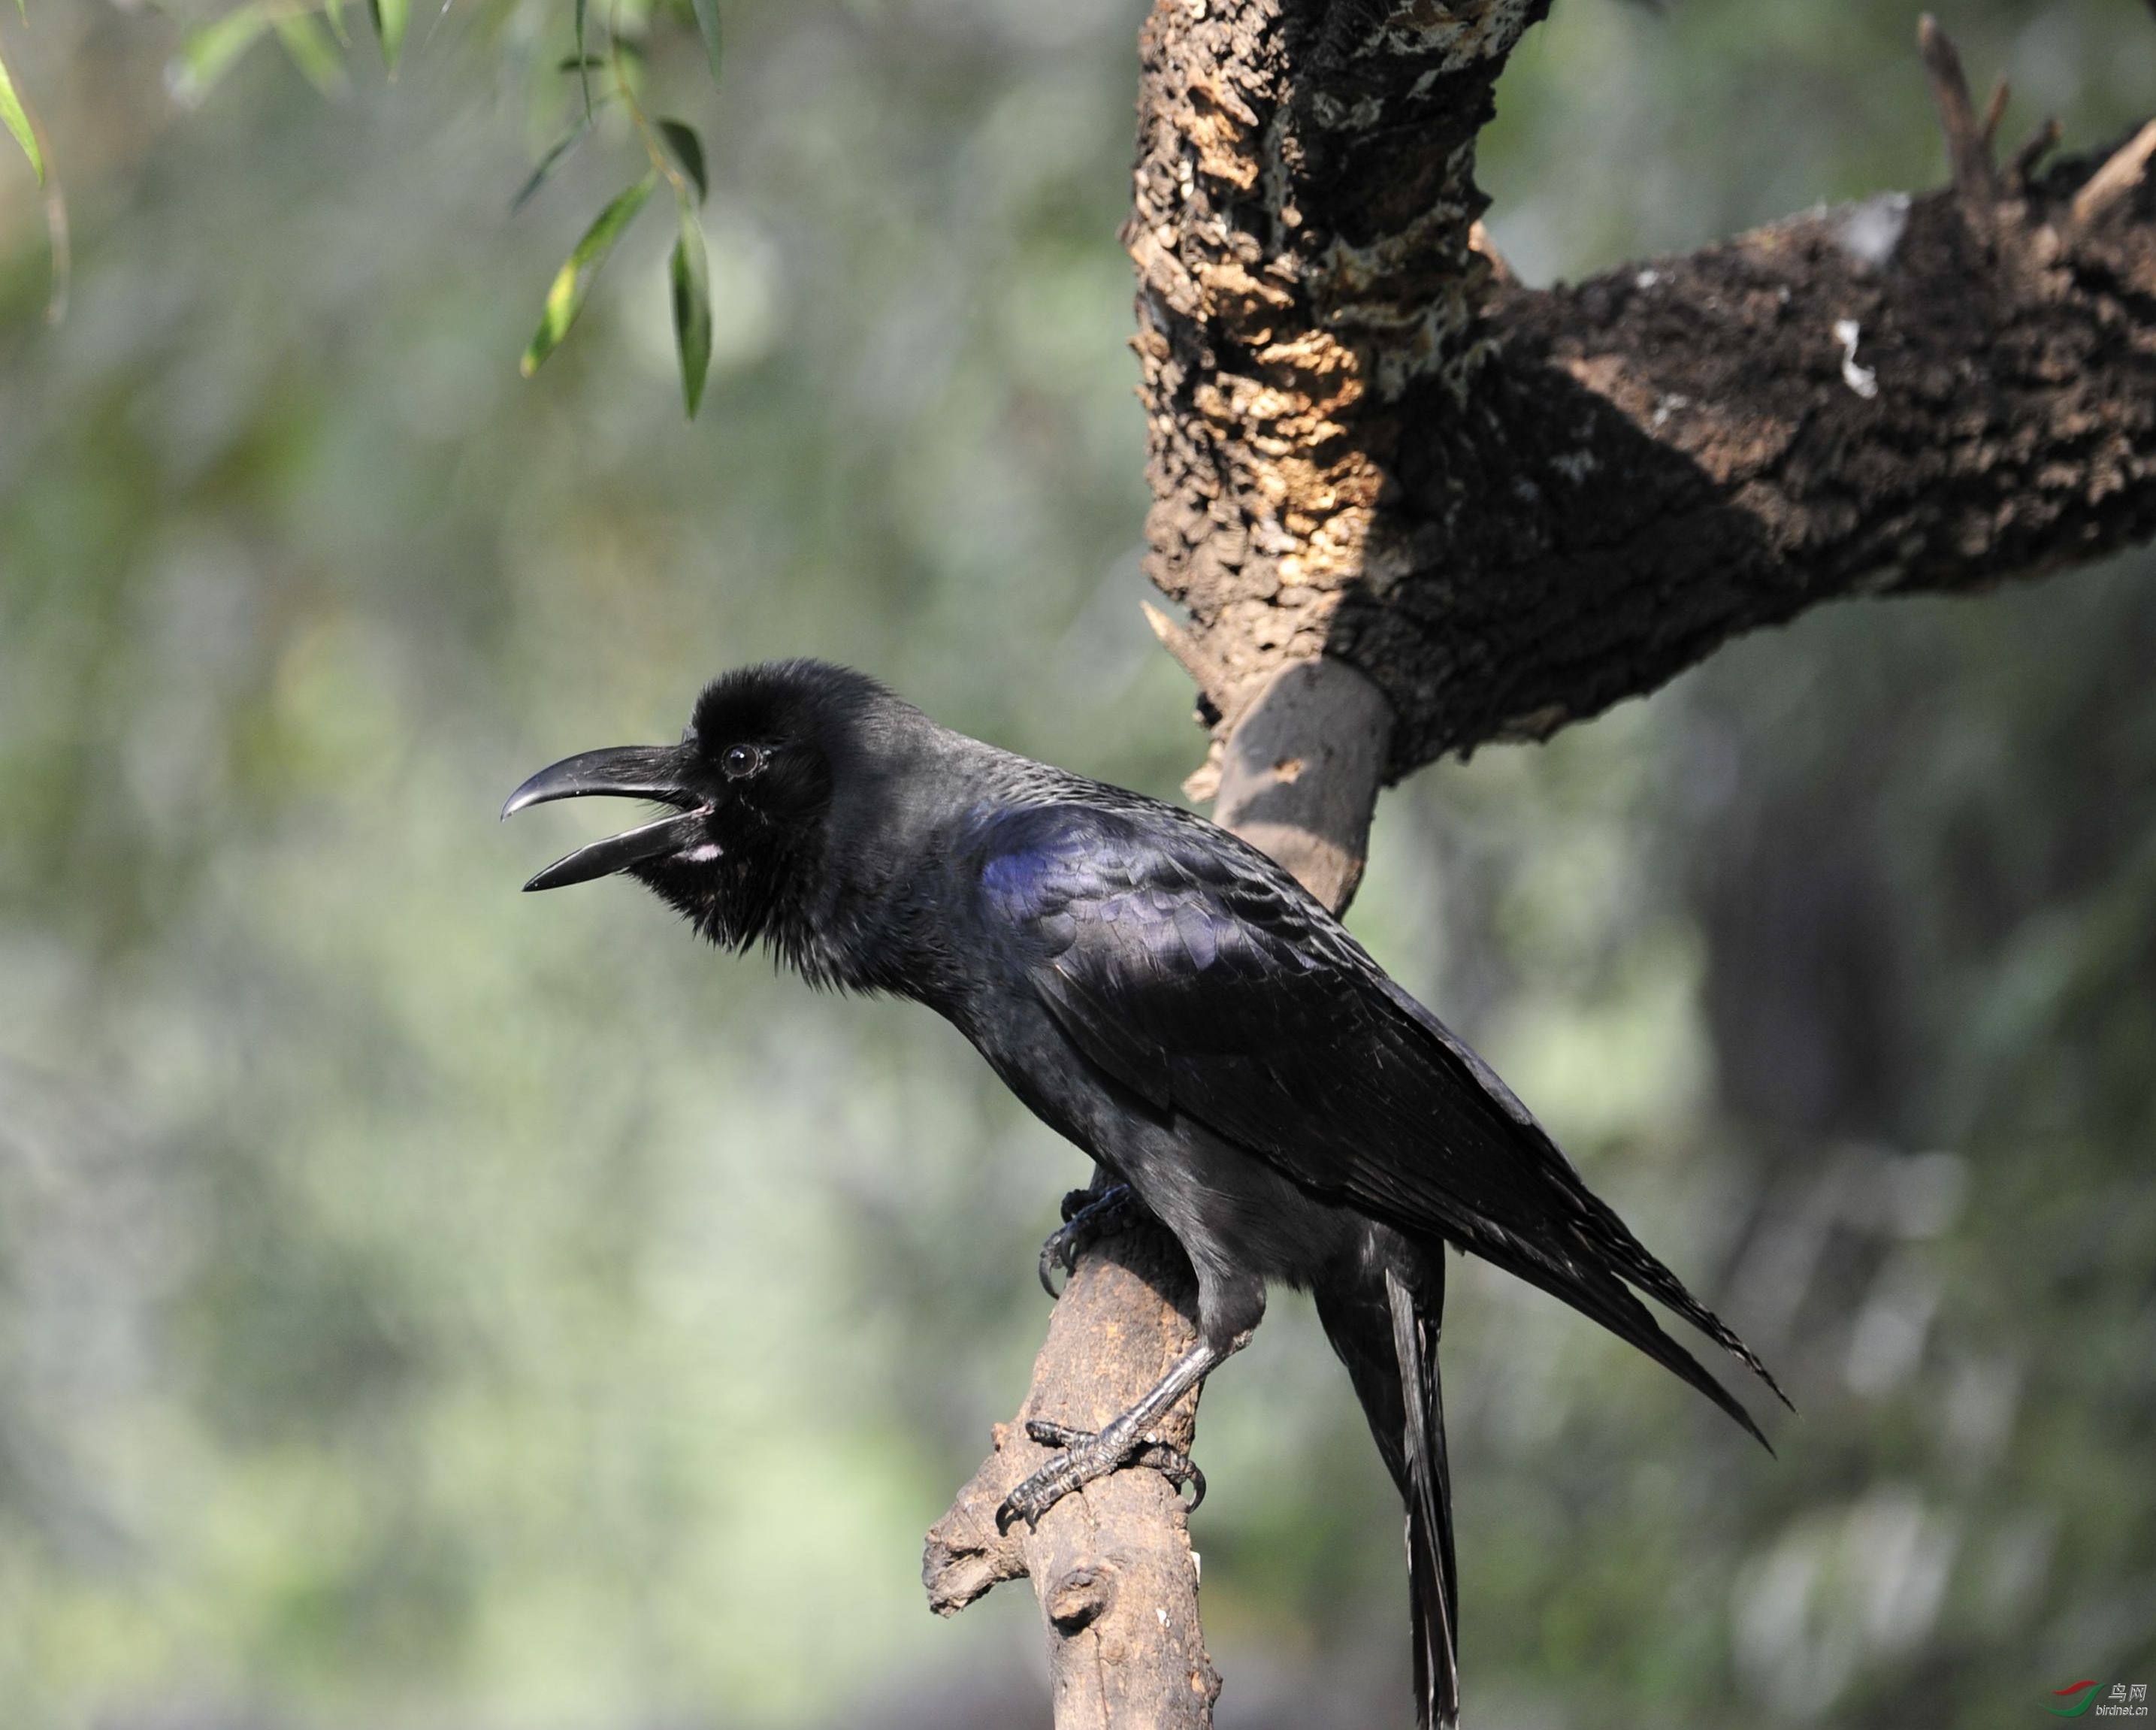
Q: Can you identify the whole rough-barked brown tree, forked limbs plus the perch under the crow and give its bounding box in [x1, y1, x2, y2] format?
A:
[925, 0, 2156, 1730]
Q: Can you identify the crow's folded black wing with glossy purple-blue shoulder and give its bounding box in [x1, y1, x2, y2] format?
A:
[972, 800, 1779, 1435]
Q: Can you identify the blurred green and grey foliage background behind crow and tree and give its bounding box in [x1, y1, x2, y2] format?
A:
[0, 0, 2156, 1730]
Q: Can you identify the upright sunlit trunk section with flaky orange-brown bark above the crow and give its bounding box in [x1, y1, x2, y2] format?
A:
[1123, 0, 1548, 764]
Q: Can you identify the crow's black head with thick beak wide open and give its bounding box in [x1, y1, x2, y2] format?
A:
[502, 660, 906, 949]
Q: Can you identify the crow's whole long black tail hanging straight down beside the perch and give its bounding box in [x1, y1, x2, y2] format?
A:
[1317, 1251, 1459, 1730]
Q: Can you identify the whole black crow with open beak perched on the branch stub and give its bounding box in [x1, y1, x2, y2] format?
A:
[502, 660, 1787, 1725]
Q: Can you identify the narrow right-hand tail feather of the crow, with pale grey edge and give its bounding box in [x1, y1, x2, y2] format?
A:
[1384, 1271, 1459, 1730]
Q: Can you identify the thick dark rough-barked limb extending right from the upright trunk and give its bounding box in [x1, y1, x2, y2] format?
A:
[1353, 141, 2156, 774]
